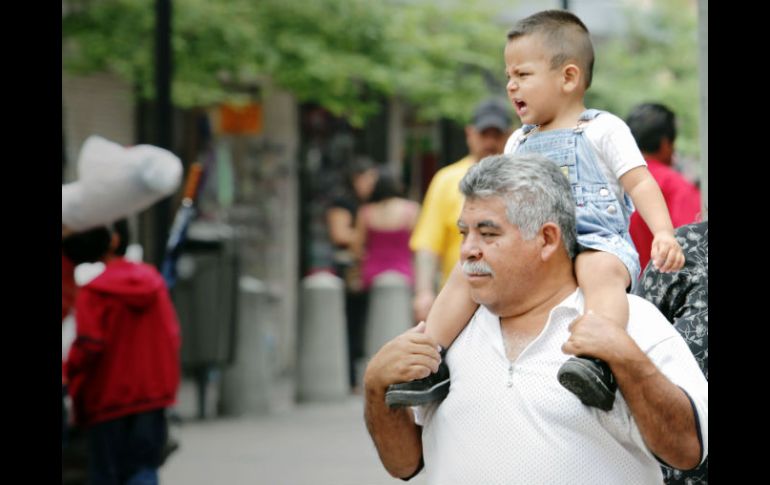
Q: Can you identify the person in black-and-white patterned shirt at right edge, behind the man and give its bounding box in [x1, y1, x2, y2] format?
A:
[636, 221, 709, 485]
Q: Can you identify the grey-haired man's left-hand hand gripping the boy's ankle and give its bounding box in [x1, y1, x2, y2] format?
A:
[364, 322, 441, 392]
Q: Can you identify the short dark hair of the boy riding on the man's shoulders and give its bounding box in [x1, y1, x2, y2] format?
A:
[508, 10, 594, 89]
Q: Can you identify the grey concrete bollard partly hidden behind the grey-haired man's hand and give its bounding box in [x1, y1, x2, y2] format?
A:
[364, 271, 413, 360]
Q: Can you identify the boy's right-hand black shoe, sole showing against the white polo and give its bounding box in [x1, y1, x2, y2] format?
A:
[557, 357, 618, 411]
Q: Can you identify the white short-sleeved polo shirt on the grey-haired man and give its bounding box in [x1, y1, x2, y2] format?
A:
[414, 290, 708, 485]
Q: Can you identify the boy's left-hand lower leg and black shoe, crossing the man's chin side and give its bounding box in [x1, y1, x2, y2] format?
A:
[385, 264, 478, 407]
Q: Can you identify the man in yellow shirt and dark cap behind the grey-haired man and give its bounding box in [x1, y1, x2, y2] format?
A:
[409, 99, 512, 321]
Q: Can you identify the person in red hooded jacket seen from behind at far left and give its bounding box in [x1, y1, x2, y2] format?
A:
[62, 220, 181, 484]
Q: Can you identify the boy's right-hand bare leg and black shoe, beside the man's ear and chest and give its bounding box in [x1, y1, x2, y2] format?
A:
[558, 250, 631, 411]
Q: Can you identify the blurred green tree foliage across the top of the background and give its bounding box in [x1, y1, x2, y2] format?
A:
[62, 0, 698, 145]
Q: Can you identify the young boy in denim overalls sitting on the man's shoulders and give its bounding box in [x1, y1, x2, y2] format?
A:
[386, 10, 684, 410]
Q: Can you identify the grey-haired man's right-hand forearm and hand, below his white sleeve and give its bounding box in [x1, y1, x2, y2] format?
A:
[562, 313, 701, 470]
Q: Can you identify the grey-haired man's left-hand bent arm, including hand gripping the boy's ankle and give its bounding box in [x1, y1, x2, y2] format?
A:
[364, 323, 440, 478]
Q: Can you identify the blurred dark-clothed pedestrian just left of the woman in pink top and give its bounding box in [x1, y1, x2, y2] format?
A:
[326, 156, 377, 390]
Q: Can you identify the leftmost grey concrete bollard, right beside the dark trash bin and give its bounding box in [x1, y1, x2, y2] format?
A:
[220, 276, 273, 416]
